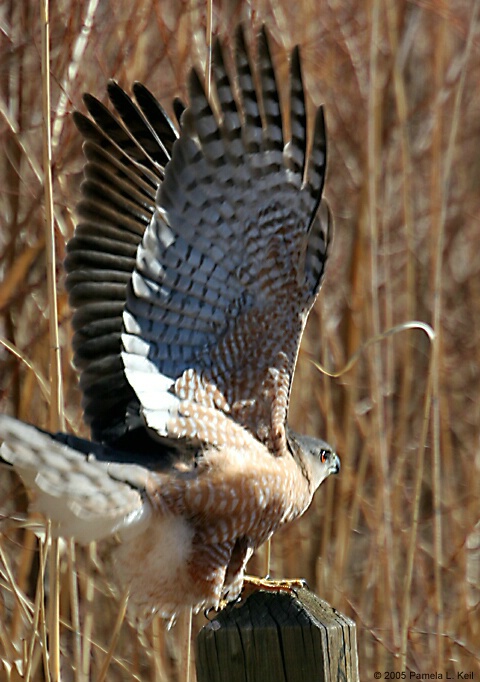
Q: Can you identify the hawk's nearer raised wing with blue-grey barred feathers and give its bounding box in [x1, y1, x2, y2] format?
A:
[123, 30, 331, 453]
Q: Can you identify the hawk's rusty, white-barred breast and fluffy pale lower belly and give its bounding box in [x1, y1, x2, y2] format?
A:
[115, 441, 311, 616]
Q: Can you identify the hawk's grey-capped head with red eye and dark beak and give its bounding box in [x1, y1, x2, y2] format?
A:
[287, 427, 340, 492]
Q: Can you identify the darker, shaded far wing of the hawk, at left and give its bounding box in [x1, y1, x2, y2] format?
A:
[65, 82, 178, 442]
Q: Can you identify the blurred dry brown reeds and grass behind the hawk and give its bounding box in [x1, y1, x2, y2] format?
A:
[0, 0, 480, 681]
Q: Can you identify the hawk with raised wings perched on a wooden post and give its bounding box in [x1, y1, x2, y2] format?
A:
[0, 28, 339, 617]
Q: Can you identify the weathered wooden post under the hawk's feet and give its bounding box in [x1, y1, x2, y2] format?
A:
[196, 588, 360, 682]
